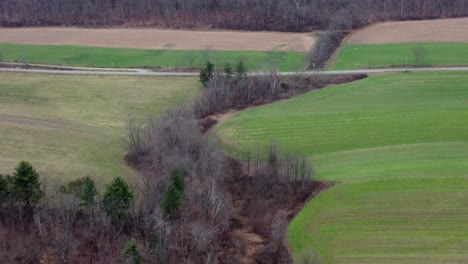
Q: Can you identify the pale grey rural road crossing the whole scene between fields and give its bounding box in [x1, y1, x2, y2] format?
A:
[0, 67, 468, 77]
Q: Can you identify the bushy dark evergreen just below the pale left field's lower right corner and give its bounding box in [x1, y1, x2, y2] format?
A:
[102, 177, 134, 222]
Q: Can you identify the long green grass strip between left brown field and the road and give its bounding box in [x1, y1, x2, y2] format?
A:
[0, 44, 305, 71]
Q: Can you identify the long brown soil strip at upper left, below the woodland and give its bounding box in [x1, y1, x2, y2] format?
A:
[0, 27, 315, 52]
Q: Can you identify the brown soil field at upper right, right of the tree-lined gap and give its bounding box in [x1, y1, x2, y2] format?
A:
[348, 18, 468, 44]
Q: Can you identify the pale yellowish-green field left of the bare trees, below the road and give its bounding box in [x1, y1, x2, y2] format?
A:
[0, 73, 198, 187]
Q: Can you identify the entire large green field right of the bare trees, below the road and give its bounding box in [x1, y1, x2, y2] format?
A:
[217, 72, 468, 263]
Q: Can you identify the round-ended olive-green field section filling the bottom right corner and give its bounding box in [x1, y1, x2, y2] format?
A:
[289, 178, 468, 264]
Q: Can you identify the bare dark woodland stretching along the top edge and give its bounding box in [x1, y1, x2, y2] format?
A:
[0, 0, 468, 31]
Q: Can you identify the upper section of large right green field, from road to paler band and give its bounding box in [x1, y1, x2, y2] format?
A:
[218, 72, 468, 173]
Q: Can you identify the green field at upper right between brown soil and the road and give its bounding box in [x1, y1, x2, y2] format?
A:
[331, 43, 468, 70]
